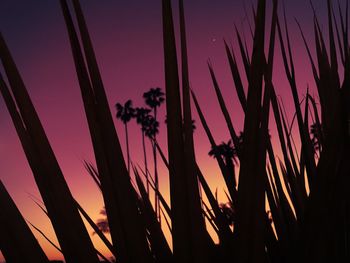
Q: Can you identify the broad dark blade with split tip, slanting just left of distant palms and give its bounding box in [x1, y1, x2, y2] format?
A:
[61, 1, 152, 262]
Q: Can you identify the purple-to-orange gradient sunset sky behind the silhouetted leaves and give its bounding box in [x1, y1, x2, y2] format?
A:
[0, 0, 340, 260]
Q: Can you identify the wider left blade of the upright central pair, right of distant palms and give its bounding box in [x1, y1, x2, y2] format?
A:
[162, 0, 195, 263]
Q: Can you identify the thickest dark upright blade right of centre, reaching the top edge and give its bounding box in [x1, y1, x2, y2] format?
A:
[235, 0, 267, 262]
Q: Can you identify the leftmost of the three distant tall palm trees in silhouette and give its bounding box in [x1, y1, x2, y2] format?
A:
[115, 100, 135, 174]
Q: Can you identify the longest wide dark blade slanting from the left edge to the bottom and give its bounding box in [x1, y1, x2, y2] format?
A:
[0, 30, 97, 262]
